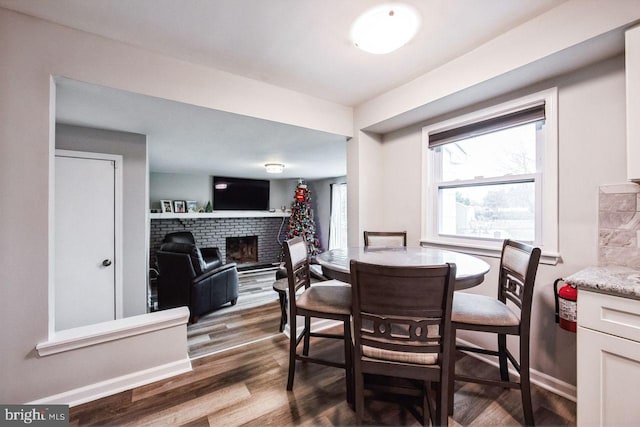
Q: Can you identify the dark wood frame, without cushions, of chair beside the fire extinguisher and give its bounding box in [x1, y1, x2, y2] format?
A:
[448, 239, 540, 426]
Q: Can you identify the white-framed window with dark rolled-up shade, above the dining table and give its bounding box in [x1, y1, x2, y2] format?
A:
[422, 89, 557, 261]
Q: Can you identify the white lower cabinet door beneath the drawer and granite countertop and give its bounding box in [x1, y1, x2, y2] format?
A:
[578, 326, 640, 426]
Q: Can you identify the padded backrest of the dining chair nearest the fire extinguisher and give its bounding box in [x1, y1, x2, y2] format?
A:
[498, 239, 540, 323]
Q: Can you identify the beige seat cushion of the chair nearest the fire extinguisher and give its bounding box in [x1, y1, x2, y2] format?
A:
[451, 292, 520, 326]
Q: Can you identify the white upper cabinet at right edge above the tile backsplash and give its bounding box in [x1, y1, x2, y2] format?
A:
[625, 26, 640, 181]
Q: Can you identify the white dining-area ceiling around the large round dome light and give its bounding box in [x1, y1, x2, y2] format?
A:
[0, 0, 564, 106]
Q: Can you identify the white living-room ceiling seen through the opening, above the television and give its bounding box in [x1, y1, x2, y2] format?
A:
[56, 78, 347, 179]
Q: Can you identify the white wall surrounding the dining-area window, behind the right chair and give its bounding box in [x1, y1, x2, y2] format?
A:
[381, 57, 626, 385]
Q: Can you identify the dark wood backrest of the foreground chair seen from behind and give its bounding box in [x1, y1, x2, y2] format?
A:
[351, 260, 456, 376]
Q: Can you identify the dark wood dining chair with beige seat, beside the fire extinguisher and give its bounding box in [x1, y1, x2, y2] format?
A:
[448, 240, 540, 425]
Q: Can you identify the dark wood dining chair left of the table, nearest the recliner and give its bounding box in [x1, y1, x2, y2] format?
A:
[283, 237, 353, 402]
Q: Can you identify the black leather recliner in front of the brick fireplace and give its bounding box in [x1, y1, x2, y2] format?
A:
[156, 243, 238, 323]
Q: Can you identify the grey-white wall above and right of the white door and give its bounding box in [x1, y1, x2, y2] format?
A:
[56, 124, 148, 317]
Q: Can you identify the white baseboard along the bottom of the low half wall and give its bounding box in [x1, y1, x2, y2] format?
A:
[28, 358, 192, 407]
